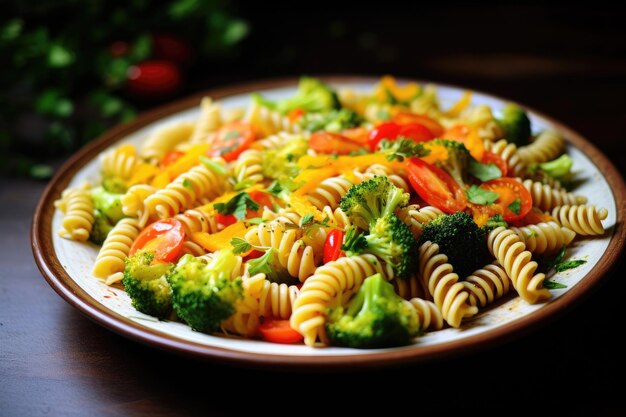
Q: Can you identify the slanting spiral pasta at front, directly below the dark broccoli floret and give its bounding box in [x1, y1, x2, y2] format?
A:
[418, 241, 478, 327]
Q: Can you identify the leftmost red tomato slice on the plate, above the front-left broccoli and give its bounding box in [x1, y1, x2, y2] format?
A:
[128, 219, 185, 262]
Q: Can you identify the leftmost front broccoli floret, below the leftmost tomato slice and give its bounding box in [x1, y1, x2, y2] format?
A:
[122, 252, 174, 318]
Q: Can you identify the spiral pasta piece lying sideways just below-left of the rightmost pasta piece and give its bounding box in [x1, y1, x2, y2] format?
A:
[511, 222, 576, 254]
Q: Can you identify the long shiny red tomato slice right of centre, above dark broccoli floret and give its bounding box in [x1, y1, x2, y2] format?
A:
[406, 158, 467, 214]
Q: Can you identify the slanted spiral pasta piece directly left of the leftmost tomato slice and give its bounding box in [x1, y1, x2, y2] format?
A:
[92, 218, 141, 285]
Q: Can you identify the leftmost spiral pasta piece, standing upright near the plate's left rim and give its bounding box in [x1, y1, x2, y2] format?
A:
[54, 183, 94, 242]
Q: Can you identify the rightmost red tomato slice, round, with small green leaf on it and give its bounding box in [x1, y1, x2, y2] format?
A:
[480, 178, 533, 222]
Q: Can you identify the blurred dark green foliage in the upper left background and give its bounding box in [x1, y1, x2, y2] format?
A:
[0, 0, 248, 178]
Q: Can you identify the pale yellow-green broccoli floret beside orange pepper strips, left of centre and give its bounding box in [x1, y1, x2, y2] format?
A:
[261, 138, 309, 179]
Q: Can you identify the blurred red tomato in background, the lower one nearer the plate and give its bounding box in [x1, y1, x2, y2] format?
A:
[126, 60, 182, 98]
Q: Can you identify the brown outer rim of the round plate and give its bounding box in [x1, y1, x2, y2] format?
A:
[31, 75, 626, 369]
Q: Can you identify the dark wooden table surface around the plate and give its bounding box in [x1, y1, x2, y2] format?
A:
[0, 4, 626, 416]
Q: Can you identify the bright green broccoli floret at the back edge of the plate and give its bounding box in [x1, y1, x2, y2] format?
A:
[253, 77, 341, 114]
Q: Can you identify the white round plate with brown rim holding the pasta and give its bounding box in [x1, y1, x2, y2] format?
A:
[31, 77, 626, 367]
